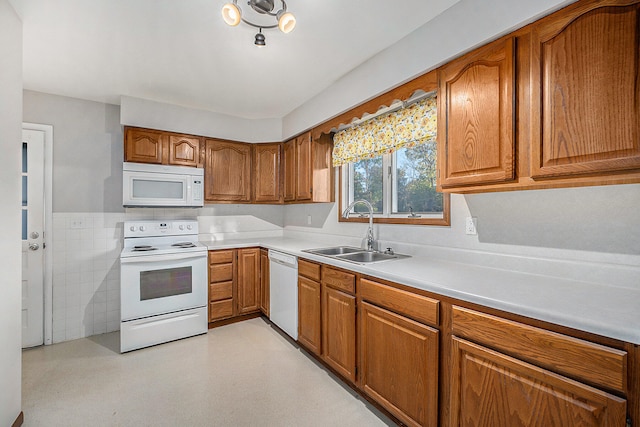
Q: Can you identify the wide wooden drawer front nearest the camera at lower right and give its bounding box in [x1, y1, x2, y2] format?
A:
[453, 306, 627, 392]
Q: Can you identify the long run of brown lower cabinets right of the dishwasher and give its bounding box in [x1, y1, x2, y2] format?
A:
[298, 259, 640, 427]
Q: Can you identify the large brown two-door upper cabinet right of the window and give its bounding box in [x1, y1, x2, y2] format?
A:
[438, 0, 640, 193]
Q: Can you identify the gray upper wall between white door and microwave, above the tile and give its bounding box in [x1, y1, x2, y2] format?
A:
[23, 90, 124, 216]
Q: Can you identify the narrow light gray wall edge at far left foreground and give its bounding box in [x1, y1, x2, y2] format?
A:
[0, 0, 22, 426]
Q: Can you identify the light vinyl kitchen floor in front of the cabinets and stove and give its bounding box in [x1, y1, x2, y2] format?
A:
[22, 318, 394, 427]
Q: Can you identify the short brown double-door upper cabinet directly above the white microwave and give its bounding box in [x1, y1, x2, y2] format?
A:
[124, 127, 202, 167]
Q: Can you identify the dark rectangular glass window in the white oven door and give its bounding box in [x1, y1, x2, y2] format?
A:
[140, 266, 193, 301]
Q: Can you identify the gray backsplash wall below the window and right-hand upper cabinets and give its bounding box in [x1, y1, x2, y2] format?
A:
[284, 178, 640, 265]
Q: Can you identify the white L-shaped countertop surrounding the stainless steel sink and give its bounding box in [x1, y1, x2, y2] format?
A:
[201, 237, 640, 344]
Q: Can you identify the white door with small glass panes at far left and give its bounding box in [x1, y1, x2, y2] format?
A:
[22, 129, 45, 348]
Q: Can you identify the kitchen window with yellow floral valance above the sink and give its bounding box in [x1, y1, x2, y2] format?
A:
[334, 96, 450, 225]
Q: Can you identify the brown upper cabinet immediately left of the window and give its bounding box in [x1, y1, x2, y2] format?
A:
[283, 132, 334, 202]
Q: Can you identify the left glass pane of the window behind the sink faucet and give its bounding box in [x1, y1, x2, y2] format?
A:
[353, 156, 383, 213]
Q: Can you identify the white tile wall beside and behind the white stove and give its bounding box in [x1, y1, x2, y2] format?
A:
[48, 206, 282, 343]
